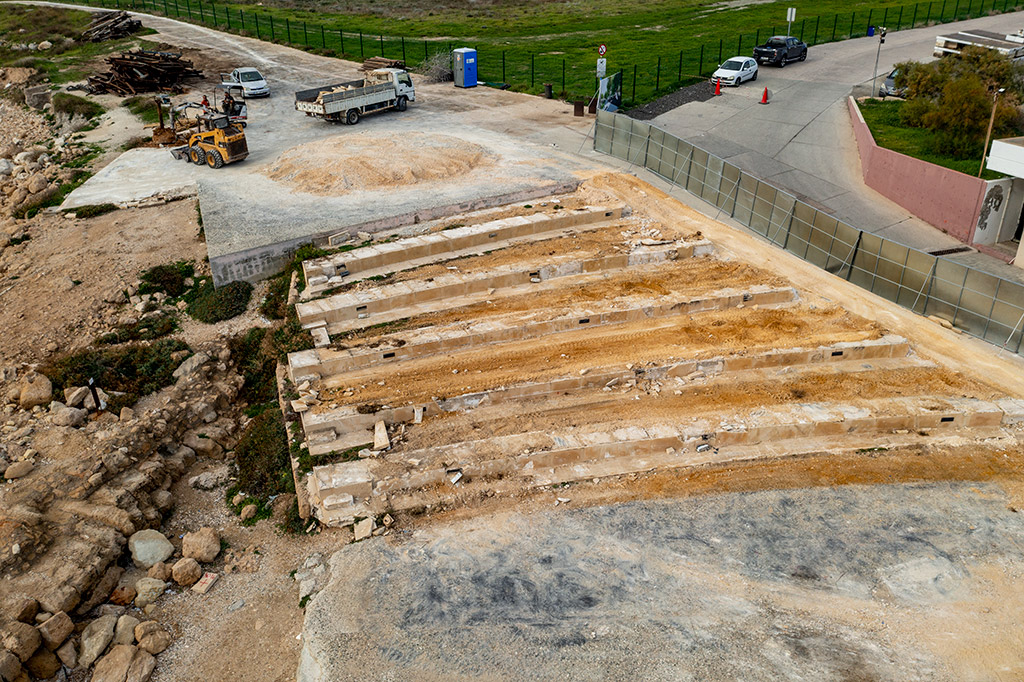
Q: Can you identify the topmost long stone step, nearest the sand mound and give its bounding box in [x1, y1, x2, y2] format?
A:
[302, 205, 628, 300]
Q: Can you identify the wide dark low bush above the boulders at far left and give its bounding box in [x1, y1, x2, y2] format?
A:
[40, 339, 188, 411]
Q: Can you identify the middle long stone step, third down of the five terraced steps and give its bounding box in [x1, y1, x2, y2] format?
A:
[288, 287, 797, 383]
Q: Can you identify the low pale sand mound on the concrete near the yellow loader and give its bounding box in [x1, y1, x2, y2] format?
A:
[263, 133, 495, 196]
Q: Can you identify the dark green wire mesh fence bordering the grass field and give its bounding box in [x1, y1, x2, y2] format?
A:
[58, 0, 1020, 106]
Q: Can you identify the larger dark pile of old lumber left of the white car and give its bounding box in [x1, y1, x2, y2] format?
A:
[89, 50, 203, 96]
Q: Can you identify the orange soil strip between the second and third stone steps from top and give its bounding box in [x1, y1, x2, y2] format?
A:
[333, 258, 788, 342]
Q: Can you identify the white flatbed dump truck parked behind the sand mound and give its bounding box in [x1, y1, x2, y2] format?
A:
[295, 69, 416, 126]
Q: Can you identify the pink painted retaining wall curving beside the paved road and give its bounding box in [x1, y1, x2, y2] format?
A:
[848, 97, 987, 244]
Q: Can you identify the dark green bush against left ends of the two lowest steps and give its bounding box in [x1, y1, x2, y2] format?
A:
[234, 410, 295, 500]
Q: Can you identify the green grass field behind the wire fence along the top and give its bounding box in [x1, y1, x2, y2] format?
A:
[25, 0, 1018, 103]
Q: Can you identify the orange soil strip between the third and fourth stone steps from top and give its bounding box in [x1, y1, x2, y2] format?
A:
[322, 308, 881, 404]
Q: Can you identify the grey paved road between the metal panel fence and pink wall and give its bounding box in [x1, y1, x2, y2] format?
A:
[653, 12, 1024, 281]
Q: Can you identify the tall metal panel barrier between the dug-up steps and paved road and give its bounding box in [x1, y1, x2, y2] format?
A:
[594, 112, 1024, 354]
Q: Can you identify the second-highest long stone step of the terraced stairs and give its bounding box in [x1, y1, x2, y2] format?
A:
[295, 240, 714, 335]
